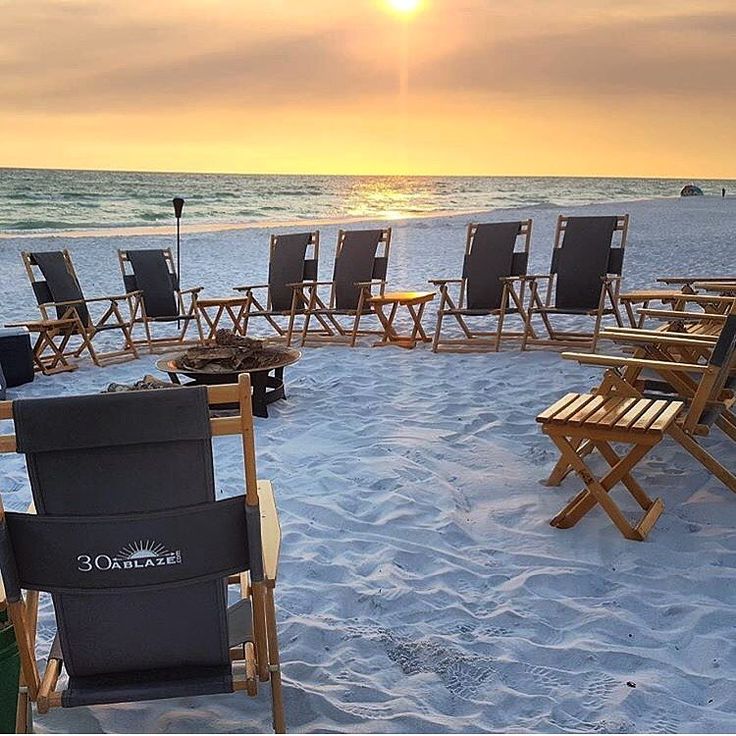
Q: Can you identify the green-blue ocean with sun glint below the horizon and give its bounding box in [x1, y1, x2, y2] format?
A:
[0, 168, 736, 235]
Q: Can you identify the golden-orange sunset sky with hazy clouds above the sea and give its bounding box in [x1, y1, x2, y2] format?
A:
[0, 0, 736, 179]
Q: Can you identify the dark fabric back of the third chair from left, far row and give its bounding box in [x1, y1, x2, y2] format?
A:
[268, 230, 319, 312]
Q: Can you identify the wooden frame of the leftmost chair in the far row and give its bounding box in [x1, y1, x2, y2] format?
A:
[17, 249, 138, 367]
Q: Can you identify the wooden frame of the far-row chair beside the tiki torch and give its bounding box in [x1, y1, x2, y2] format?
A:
[118, 248, 205, 353]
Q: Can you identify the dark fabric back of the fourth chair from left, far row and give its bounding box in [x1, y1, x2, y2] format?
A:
[331, 227, 391, 310]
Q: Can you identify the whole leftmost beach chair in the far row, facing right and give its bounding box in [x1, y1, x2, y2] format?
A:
[21, 250, 138, 366]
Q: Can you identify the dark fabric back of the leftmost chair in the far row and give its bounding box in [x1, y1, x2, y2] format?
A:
[22, 250, 90, 327]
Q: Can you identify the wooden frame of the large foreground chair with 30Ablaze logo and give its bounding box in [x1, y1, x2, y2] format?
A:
[0, 374, 286, 733]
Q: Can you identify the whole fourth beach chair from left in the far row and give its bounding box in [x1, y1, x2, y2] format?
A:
[291, 227, 391, 347]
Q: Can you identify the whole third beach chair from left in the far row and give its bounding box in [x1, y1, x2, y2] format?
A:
[235, 230, 319, 344]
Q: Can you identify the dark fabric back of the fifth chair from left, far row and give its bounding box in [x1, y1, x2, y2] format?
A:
[463, 220, 532, 309]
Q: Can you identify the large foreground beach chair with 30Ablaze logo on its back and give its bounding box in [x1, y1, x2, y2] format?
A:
[0, 375, 285, 732]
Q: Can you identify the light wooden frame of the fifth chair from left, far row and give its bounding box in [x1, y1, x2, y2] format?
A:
[429, 219, 532, 353]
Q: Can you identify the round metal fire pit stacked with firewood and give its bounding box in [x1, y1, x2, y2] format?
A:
[156, 330, 301, 417]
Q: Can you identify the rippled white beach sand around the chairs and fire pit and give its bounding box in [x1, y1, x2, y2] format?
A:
[0, 199, 736, 732]
